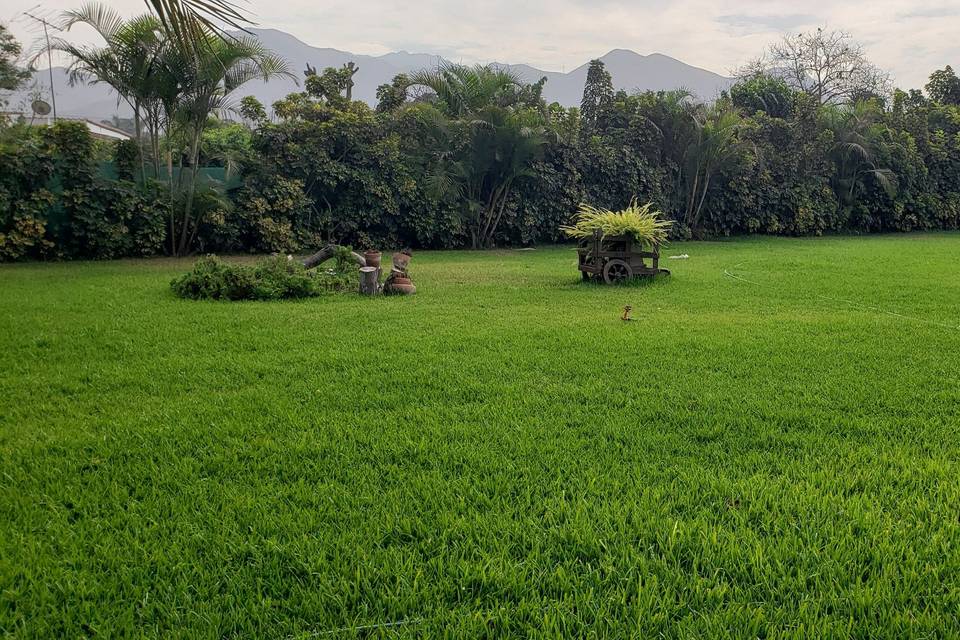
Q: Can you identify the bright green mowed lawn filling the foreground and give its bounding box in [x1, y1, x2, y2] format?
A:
[0, 234, 960, 638]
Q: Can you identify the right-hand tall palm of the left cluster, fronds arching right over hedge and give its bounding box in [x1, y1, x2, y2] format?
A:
[163, 35, 292, 255]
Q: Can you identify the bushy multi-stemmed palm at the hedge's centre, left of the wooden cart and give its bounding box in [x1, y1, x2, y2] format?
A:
[410, 65, 546, 248]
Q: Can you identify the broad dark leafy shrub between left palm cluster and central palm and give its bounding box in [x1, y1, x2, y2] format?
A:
[235, 87, 432, 250]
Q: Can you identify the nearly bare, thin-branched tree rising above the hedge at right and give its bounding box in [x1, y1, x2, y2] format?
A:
[739, 29, 890, 104]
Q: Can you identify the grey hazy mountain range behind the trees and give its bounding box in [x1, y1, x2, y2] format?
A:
[9, 29, 732, 120]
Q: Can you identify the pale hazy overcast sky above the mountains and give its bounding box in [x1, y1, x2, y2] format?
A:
[7, 0, 960, 88]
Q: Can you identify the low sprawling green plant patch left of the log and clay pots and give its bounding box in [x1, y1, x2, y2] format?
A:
[170, 256, 348, 300]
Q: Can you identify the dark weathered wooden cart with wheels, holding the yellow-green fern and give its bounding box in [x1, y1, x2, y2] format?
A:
[577, 232, 670, 284]
